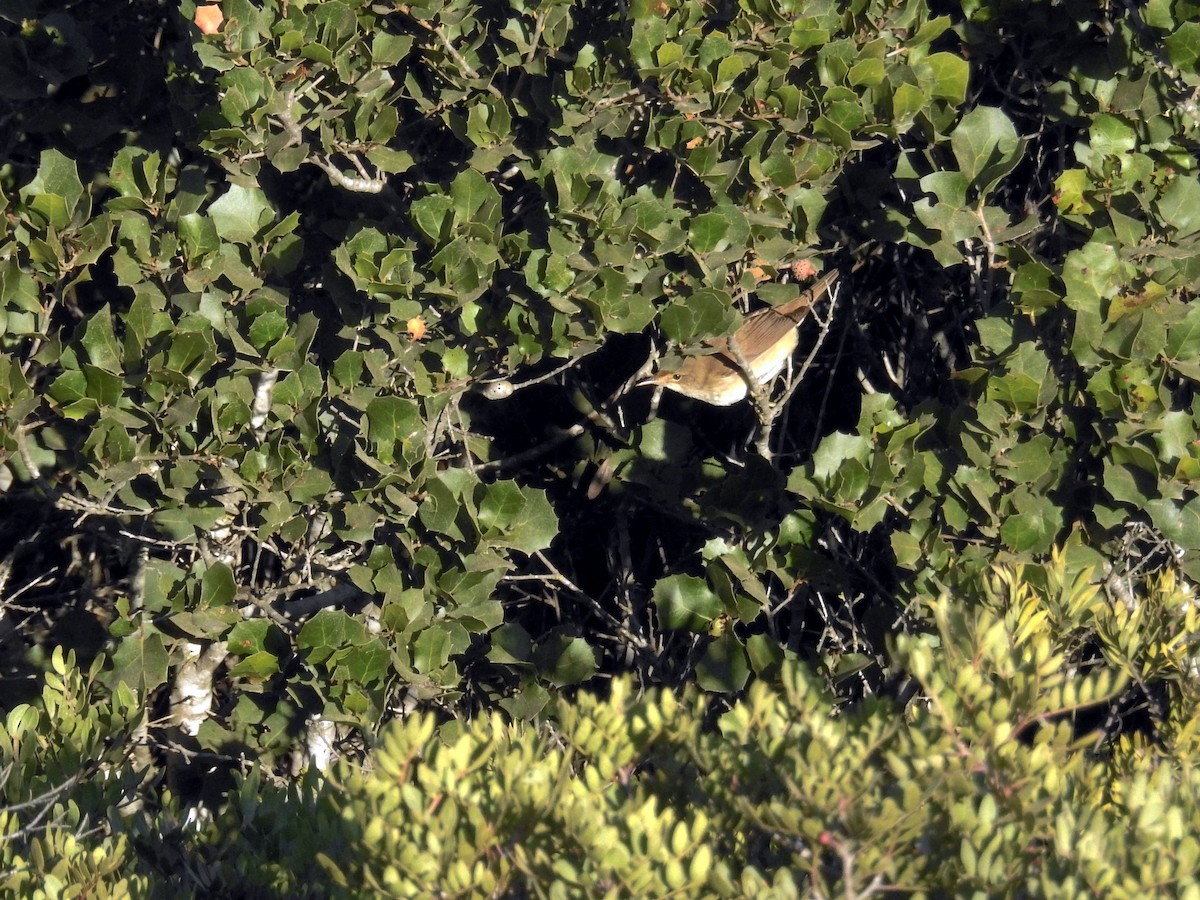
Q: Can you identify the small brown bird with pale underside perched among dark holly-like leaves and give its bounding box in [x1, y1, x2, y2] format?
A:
[637, 271, 838, 407]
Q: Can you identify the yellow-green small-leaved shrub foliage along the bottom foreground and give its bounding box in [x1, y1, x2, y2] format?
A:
[9, 558, 1200, 896]
